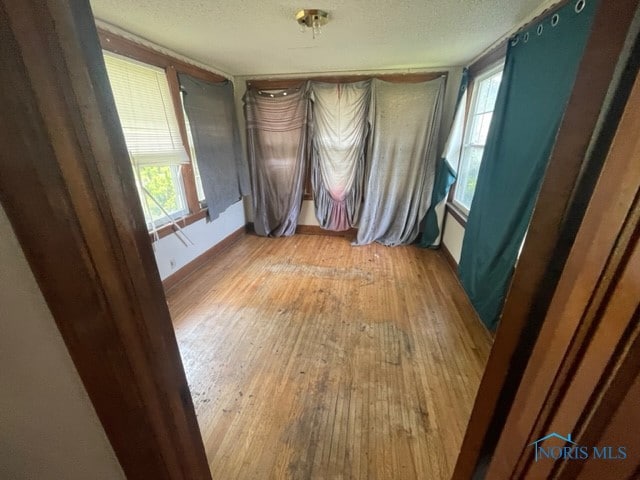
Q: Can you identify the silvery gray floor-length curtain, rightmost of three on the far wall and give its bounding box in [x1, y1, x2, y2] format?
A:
[355, 78, 444, 245]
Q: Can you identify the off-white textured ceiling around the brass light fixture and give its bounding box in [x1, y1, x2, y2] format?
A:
[91, 0, 551, 75]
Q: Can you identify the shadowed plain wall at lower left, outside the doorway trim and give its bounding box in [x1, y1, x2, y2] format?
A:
[0, 207, 124, 480]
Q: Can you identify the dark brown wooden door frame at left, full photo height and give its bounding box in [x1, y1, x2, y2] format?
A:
[0, 0, 211, 480]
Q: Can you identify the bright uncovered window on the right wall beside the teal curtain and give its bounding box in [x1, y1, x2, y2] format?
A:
[453, 65, 502, 214]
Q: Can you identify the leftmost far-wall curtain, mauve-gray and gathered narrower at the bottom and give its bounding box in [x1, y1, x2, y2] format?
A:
[244, 84, 310, 237]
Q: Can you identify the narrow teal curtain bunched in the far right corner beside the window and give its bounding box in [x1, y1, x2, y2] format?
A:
[418, 68, 469, 248]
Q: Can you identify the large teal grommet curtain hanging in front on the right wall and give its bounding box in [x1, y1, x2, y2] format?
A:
[458, 0, 597, 330]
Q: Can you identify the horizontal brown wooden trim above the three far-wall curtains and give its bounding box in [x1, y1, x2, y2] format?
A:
[247, 71, 448, 90]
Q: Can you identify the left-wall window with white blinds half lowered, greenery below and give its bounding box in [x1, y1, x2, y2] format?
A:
[104, 52, 189, 229]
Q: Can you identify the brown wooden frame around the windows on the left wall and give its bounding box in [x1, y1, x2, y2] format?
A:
[98, 27, 227, 240]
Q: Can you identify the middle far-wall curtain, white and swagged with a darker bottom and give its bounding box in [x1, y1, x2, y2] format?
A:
[311, 80, 371, 231]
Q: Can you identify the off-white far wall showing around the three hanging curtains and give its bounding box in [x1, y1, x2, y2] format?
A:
[234, 67, 462, 226]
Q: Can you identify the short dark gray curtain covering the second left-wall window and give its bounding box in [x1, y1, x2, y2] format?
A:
[179, 74, 251, 220]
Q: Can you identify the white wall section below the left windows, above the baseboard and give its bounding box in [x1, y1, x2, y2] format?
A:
[153, 200, 247, 280]
